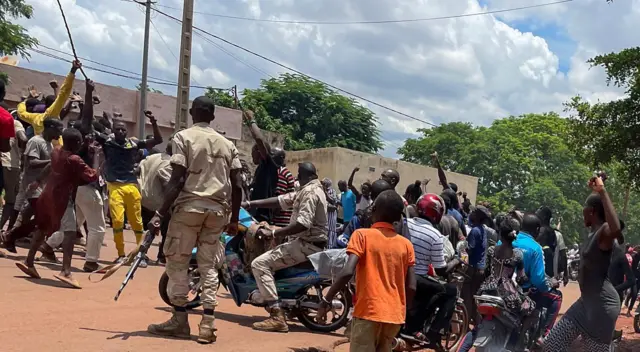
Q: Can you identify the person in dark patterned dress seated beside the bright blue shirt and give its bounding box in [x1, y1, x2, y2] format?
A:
[457, 216, 535, 352]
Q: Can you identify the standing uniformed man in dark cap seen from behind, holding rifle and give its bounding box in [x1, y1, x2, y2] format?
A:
[146, 96, 242, 343]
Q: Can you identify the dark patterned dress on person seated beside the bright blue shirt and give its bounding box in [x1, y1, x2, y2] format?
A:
[478, 246, 535, 315]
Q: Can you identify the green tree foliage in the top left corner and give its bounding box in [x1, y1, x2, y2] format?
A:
[0, 0, 38, 58]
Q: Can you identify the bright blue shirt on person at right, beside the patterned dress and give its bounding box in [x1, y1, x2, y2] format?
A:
[497, 231, 550, 292]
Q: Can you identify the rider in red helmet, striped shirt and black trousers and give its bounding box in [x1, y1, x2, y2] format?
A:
[404, 193, 460, 345]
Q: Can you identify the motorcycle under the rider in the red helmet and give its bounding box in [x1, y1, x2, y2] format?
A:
[392, 268, 469, 351]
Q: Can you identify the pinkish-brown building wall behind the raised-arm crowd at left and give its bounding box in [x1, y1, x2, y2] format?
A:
[0, 65, 242, 140]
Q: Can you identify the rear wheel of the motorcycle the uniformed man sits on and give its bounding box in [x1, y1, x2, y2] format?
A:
[295, 281, 353, 333]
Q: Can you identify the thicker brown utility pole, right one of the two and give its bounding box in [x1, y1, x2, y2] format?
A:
[174, 0, 193, 131]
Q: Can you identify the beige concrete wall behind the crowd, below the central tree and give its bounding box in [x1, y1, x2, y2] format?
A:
[287, 148, 478, 204]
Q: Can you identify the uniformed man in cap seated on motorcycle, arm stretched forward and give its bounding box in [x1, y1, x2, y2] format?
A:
[248, 163, 327, 332]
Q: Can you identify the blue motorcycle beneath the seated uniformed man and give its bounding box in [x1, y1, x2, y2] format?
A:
[159, 209, 352, 332]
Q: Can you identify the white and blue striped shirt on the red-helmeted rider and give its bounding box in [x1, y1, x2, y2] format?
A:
[407, 218, 447, 276]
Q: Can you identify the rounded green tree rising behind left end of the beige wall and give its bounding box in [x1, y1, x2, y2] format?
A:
[242, 74, 382, 153]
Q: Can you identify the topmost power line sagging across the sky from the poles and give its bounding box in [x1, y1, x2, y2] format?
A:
[152, 0, 574, 25]
